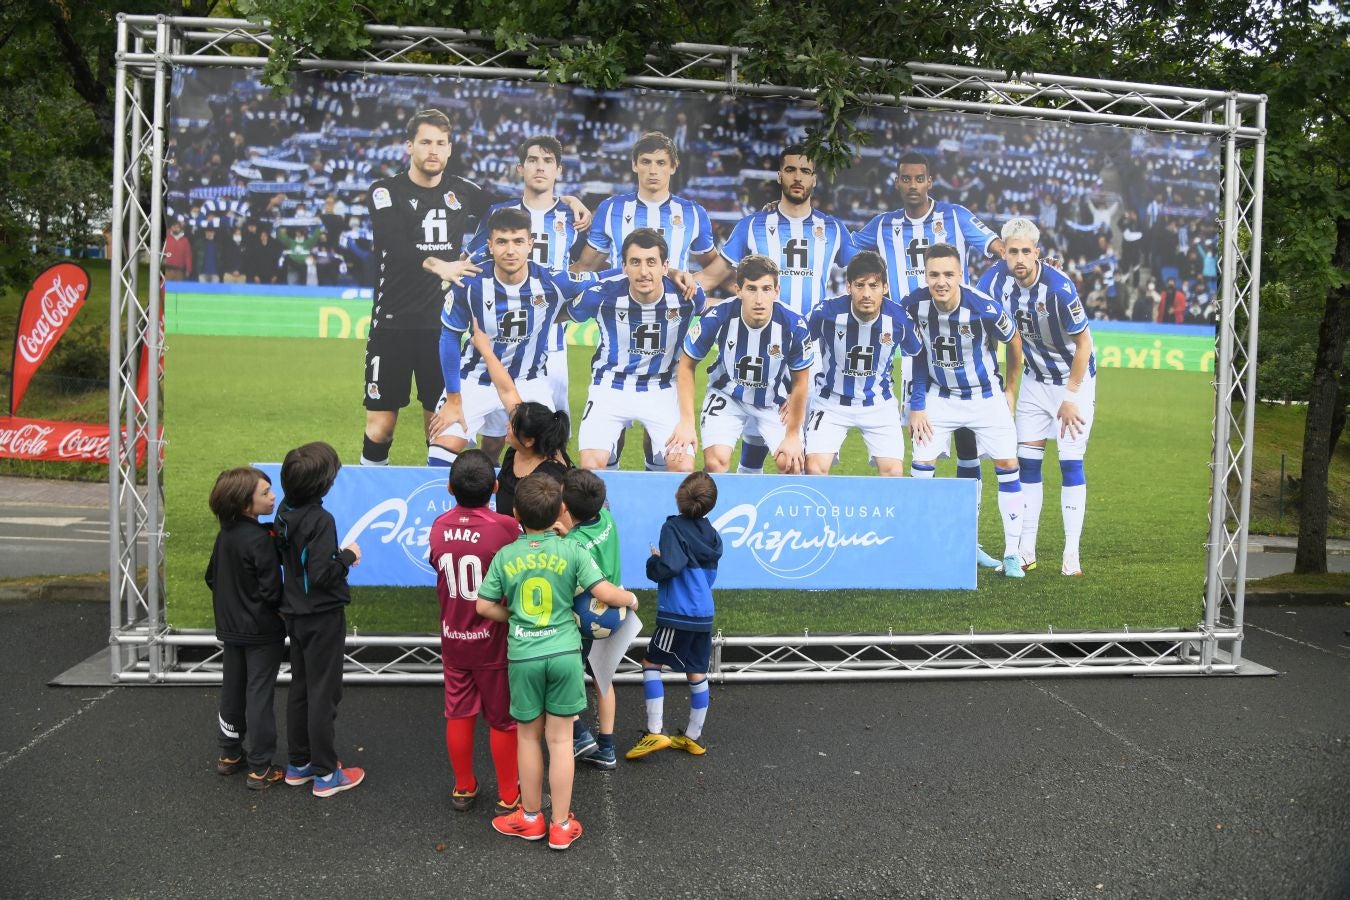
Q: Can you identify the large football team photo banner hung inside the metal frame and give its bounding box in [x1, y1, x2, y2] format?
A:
[165, 67, 1222, 625]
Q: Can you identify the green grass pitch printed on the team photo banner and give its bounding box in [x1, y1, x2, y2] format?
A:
[163, 335, 1214, 634]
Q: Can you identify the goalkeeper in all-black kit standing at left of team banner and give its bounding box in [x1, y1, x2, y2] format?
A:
[360, 109, 487, 466]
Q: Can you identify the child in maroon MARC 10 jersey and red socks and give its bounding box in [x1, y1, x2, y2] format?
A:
[429, 449, 520, 815]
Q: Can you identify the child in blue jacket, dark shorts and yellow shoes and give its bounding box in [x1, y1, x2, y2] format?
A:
[624, 472, 722, 760]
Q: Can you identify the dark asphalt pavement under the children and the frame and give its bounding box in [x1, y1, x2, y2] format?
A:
[0, 600, 1350, 900]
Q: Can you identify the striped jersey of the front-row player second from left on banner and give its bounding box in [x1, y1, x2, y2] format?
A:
[567, 275, 706, 391]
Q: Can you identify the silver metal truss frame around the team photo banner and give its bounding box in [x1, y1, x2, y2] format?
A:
[108, 15, 1266, 683]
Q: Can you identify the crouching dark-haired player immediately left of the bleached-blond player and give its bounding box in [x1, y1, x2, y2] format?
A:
[905, 244, 1023, 578]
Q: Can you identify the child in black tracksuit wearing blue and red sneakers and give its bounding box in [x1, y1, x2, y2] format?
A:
[275, 441, 366, 797]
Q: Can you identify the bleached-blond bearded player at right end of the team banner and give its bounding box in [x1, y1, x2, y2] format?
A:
[980, 217, 1096, 575]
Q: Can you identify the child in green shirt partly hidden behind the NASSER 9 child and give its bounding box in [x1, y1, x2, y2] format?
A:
[563, 468, 624, 770]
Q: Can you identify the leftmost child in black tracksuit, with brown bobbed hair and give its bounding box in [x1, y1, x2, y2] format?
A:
[207, 466, 286, 791]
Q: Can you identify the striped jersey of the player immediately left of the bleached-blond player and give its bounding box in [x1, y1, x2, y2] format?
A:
[903, 285, 1015, 409]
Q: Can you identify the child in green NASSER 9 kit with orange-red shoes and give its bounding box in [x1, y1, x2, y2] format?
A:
[477, 472, 637, 850]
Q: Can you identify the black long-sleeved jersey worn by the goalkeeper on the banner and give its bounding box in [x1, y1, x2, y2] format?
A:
[370, 171, 487, 331]
